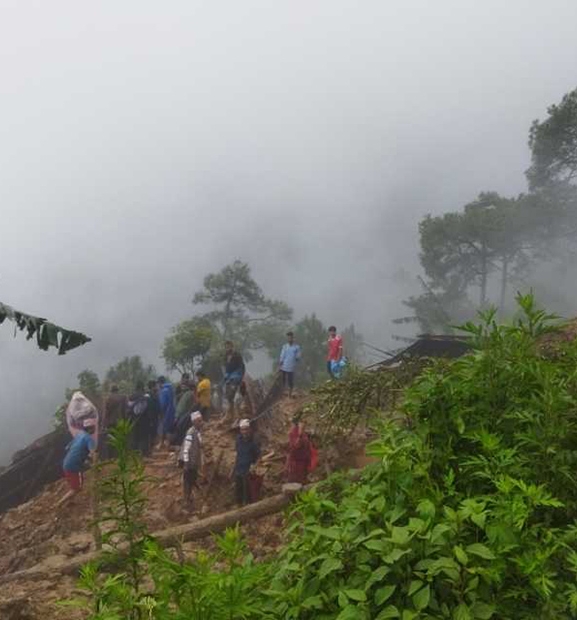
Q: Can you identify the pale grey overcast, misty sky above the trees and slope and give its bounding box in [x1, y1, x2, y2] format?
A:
[0, 0, 577, 462]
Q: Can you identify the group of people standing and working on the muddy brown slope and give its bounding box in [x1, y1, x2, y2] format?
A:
[61, 326, 343, 505]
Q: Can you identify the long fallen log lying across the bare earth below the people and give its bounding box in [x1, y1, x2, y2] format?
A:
[0, 486, 302, 584]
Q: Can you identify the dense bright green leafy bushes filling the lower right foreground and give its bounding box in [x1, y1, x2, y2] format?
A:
[72, 297, 577, 620]
